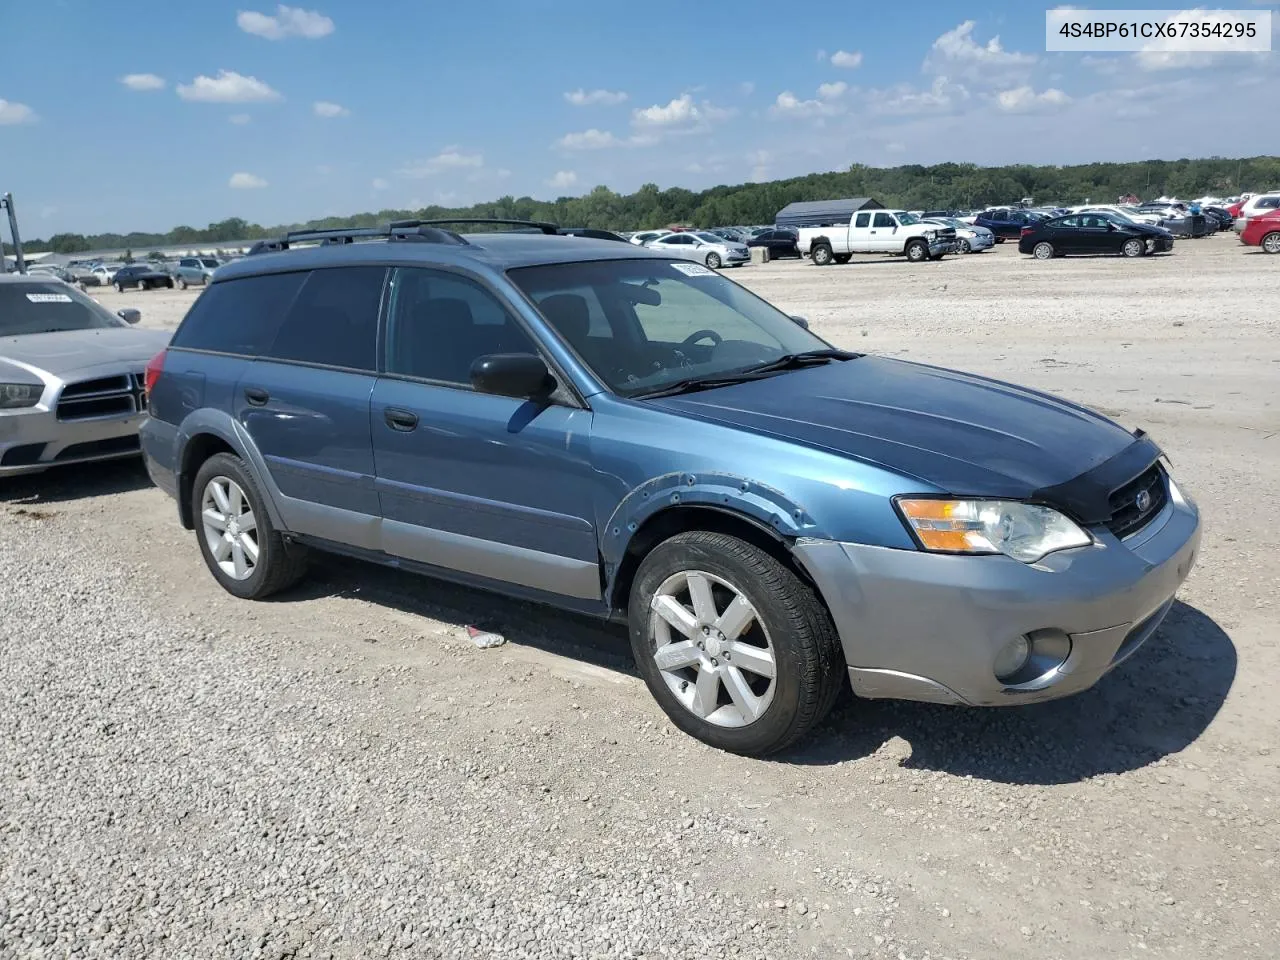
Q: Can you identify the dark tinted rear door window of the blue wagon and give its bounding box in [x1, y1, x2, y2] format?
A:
[266, 266, 387, 370]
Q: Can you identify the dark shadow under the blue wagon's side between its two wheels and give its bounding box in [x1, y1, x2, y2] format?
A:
[275, 554, 639, 676]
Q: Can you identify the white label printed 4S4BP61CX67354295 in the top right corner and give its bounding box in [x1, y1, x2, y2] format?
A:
[1044, 6, 1272, 51]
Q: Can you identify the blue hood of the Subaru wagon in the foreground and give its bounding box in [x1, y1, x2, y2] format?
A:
[646, 357, 1134, 497]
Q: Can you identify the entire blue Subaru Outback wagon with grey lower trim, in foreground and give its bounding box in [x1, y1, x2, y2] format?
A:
[142, 221, 1199, 755]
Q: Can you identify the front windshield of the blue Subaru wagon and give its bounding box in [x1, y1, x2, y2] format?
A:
[508, 259, 829, 397]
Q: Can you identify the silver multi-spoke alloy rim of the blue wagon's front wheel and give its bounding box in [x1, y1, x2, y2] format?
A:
[649, 570, 777, 727]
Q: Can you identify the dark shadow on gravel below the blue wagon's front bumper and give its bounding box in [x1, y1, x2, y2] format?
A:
[778, 602, 1236, 785]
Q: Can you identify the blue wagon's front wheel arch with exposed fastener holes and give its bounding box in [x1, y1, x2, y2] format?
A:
[600, 472, 824, 607]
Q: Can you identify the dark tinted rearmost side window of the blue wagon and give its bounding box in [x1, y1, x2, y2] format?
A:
[170, 273, 307, 357]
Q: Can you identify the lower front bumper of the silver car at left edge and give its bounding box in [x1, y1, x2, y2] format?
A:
[0, 410, 146, 476]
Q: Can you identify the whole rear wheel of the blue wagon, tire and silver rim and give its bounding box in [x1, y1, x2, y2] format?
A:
[191, 453, 307, 600]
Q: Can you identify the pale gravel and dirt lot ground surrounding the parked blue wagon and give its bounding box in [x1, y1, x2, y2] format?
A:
[0, 236, 1280, 960]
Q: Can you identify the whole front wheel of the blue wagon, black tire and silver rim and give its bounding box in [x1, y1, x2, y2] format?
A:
[628, 531, 845, 756]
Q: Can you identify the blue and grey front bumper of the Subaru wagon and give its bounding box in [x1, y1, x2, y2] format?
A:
[795, 490, 1199, 707]
